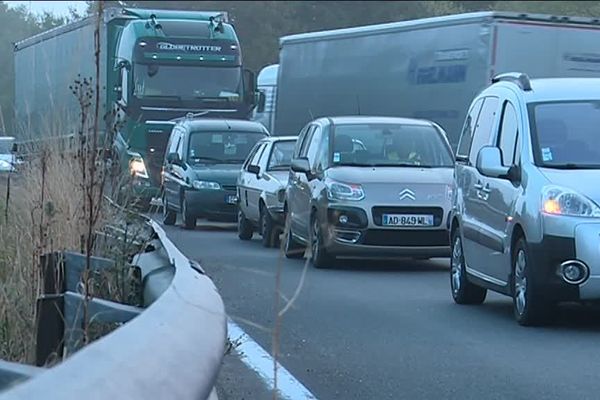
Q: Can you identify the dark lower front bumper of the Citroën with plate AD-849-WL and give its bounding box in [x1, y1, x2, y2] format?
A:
[324, 206, 450, 257]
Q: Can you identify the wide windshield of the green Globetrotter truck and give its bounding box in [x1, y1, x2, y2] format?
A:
[133, 63, 242, 101]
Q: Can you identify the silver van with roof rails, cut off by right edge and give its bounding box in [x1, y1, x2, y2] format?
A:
[450, 73, 600, 325]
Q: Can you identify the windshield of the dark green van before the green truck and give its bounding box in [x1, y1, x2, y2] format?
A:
[188, 131, 265, 164]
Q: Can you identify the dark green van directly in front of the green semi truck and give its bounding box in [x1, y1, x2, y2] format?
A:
[162, 119, 269, 229]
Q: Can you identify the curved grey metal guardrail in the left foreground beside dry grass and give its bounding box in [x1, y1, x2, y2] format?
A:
[0, 220, 227, 400]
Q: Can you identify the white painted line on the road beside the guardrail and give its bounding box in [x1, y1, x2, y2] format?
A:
[227, 319, 317, 400]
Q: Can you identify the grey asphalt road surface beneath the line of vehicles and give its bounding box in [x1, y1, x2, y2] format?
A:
[167, 220, 600, 400]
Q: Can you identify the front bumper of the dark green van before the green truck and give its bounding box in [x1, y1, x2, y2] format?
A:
[185, 189, 238, 220]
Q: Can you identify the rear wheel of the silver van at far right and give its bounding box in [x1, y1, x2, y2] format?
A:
[450, 230, 487, 304]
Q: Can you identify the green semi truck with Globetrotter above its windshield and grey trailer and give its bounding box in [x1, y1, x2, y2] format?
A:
[14, 7, 261, 204]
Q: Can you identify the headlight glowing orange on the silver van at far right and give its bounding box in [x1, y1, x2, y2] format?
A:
[542, 186, 600, 218]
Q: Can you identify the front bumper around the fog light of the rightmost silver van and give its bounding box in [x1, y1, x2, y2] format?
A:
[528, 223, 600, 301]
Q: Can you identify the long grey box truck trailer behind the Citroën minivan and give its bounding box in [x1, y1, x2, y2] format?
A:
[273, 12, 600, 148]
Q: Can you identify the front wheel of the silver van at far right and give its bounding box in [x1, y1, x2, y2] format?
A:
[511, 238, 556, 326]
